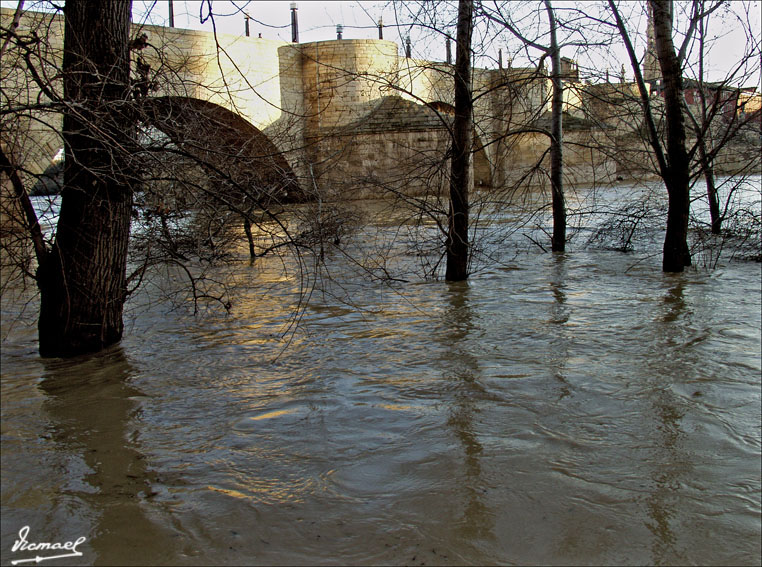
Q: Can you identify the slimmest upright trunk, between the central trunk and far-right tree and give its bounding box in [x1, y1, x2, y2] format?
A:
[545, 0, 566, 252]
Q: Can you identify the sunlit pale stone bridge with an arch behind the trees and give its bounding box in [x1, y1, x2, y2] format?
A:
[1, 9, 611, 205]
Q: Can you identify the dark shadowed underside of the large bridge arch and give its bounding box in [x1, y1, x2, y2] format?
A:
[142, 96, 304, 204]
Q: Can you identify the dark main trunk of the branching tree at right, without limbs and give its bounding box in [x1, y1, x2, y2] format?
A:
[650, 0, 691, 272]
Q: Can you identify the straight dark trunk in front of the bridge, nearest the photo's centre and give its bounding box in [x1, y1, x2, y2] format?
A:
[445, 0, 474, 281]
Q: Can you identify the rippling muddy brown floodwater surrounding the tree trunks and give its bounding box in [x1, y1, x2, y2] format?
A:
[2, 184, 762, 565]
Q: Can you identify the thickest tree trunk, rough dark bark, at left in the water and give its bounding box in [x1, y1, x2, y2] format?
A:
[38, 0, 134, 356]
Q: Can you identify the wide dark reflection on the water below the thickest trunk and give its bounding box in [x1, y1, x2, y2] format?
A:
[39, 347, 176, 565]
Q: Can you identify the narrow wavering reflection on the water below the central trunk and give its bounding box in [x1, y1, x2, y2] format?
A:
[440, 282, 494, 542]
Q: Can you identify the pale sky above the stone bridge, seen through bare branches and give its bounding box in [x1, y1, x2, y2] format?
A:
[0, 0, 762, 88]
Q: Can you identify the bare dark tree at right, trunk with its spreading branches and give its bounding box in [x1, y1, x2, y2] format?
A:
[609, 0, 759, 272]
